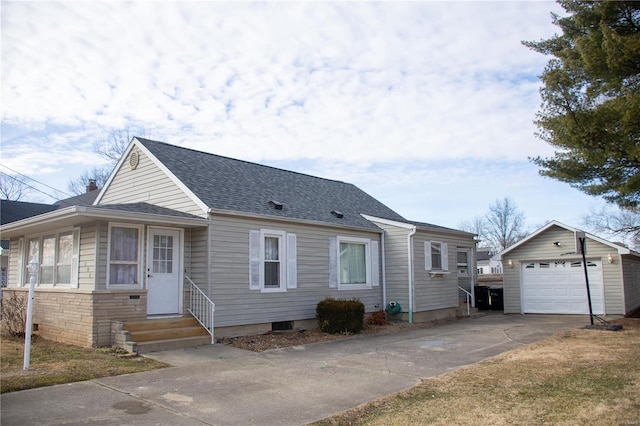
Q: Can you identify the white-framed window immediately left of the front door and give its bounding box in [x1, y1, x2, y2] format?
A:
[108, 225, 142, 286]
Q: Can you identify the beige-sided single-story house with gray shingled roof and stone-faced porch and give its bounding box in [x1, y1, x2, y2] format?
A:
[2, 138, 475, 346]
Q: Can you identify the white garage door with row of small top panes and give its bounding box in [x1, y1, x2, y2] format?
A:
[522, 260, 604, 315]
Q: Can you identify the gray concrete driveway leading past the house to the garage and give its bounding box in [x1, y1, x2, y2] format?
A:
[0, 313, 589, 426]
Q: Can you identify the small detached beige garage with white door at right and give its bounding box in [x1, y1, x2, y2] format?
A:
[500, 221, 640, 315]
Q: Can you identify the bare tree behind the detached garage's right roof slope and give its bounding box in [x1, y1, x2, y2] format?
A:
[582, 207, 640, 249]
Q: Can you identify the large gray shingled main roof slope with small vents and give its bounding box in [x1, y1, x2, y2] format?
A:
[135, 138, 405, 229]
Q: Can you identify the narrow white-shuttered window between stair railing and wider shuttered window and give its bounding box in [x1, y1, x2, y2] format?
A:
[249, 229, 298, 293]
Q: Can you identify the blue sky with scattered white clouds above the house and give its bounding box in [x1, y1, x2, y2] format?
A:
[0, 1, 601, 233]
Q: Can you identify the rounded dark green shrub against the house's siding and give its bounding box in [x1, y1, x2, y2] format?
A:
[316, 297, 364, 334]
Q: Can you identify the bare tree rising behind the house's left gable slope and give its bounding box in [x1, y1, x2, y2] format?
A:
[67, 129, 131, 195]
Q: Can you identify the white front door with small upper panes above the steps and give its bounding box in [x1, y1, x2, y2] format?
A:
[147, 228, 182, 315]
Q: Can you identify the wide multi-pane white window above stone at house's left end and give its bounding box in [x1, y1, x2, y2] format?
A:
[22, 230, 80, 286]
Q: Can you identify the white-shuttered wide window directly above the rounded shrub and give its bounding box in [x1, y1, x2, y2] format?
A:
[329, 237, 379, 290]
